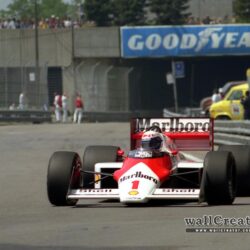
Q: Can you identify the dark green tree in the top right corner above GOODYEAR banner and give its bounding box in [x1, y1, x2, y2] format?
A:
[233, 0, 250, 23]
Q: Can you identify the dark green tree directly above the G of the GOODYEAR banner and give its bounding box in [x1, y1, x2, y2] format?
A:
[113, 0, 146, 26]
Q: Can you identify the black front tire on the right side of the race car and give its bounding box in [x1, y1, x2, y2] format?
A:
[202, 151, 236, 205]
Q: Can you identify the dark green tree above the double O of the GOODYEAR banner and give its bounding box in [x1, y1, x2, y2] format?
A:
[148, 0, 189, 25]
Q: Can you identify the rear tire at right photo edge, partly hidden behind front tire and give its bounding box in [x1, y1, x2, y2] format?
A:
[218, 145, 250, 196]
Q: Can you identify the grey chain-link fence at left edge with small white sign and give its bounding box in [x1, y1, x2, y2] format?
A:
[0, 66, 48, 109]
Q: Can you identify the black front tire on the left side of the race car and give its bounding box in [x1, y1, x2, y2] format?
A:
[47, 151, 81, 206]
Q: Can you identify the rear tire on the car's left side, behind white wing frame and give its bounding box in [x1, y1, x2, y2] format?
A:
[82, 146, 119, 188]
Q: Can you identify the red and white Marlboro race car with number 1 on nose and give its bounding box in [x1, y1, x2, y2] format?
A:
[47, 118, 250, 206]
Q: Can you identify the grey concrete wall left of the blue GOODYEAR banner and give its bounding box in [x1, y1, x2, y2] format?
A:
[0, 27, 120, 67]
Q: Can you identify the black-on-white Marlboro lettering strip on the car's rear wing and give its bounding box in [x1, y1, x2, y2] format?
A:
[136, 118, 210, 132]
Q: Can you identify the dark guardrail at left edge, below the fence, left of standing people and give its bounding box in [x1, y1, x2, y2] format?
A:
[0, 110, 52, 123]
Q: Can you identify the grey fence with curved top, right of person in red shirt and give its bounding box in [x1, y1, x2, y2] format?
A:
[75, 60, 133, 111]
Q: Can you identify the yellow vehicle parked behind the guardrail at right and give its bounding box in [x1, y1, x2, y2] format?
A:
[209, 83, 249, 120]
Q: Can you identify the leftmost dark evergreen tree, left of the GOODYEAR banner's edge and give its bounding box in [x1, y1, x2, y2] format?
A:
[83, 0, 113, 26]
